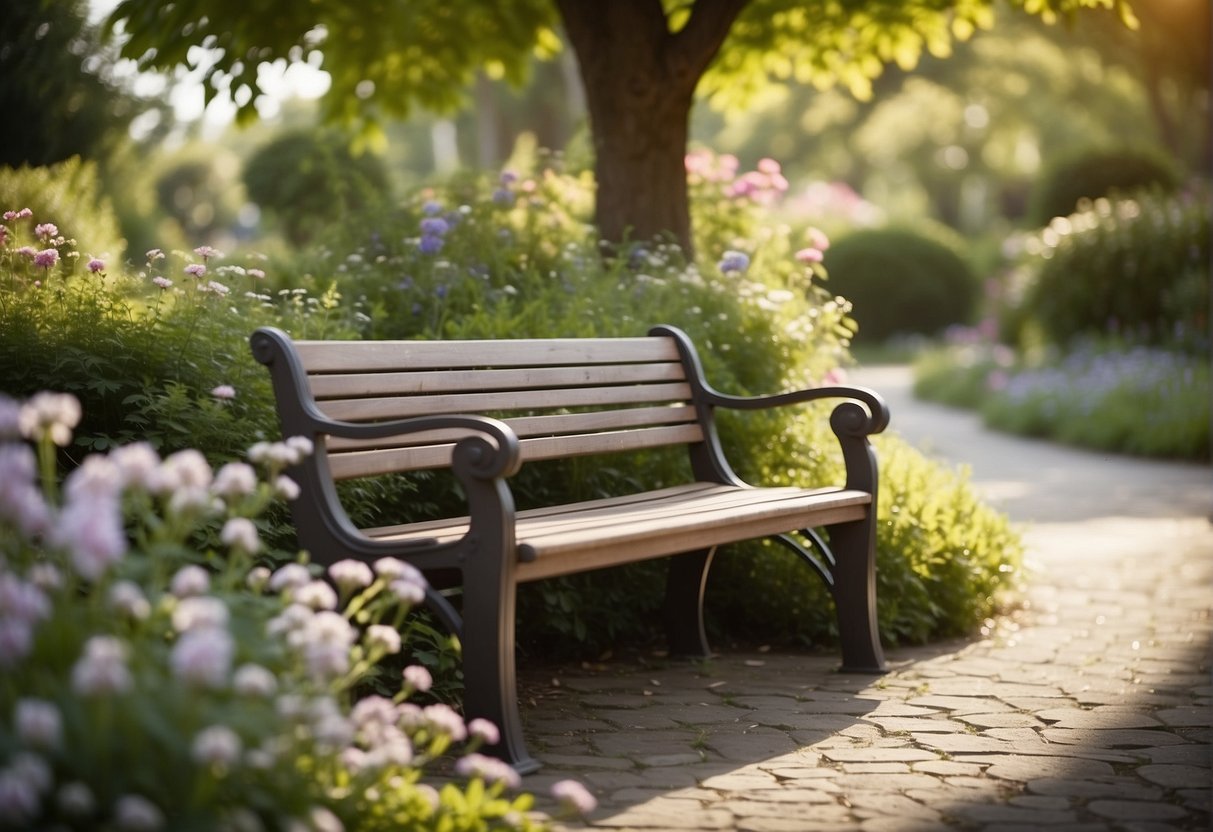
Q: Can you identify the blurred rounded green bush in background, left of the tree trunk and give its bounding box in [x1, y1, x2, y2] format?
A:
[244, 130, 391, 245]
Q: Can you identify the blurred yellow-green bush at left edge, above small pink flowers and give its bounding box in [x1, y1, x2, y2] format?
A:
[0, 156, 126, 262]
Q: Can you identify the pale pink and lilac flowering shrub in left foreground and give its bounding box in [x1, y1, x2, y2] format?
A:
[0, 393, 592, 832]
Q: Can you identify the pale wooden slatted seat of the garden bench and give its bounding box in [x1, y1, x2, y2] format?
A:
[366, 483, 871, 581]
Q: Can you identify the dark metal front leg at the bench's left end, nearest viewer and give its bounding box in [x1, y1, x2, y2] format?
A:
[462, 558, 540, 774]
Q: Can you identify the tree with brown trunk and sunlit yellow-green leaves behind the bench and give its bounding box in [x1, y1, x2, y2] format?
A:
[101, 0, 1134, 246]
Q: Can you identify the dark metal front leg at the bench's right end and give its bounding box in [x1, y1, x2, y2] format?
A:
[830, 518, 887, 673]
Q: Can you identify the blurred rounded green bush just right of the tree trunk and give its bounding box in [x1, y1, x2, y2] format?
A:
[825, 228, 978, 343]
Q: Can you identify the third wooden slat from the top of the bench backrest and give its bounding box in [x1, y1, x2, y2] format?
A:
[318, 382, 690, 422]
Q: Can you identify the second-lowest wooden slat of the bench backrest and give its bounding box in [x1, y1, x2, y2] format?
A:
[325, 405, 695, 448]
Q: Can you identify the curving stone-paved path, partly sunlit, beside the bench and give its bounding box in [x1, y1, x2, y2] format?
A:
[523, 367, 1213, 832]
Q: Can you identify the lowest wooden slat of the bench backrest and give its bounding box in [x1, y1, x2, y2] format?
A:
[329, 423, 704, 479]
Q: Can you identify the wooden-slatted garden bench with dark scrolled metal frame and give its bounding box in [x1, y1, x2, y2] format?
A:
[251, 326, 888, 773]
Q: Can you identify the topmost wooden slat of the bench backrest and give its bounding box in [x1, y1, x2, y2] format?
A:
[295, 337, 679, 374]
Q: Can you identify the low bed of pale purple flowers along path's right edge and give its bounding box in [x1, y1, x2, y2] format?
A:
[915, 340, 1213, 460]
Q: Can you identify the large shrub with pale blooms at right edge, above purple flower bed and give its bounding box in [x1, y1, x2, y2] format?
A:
[1021, 192, 1209, 348]
